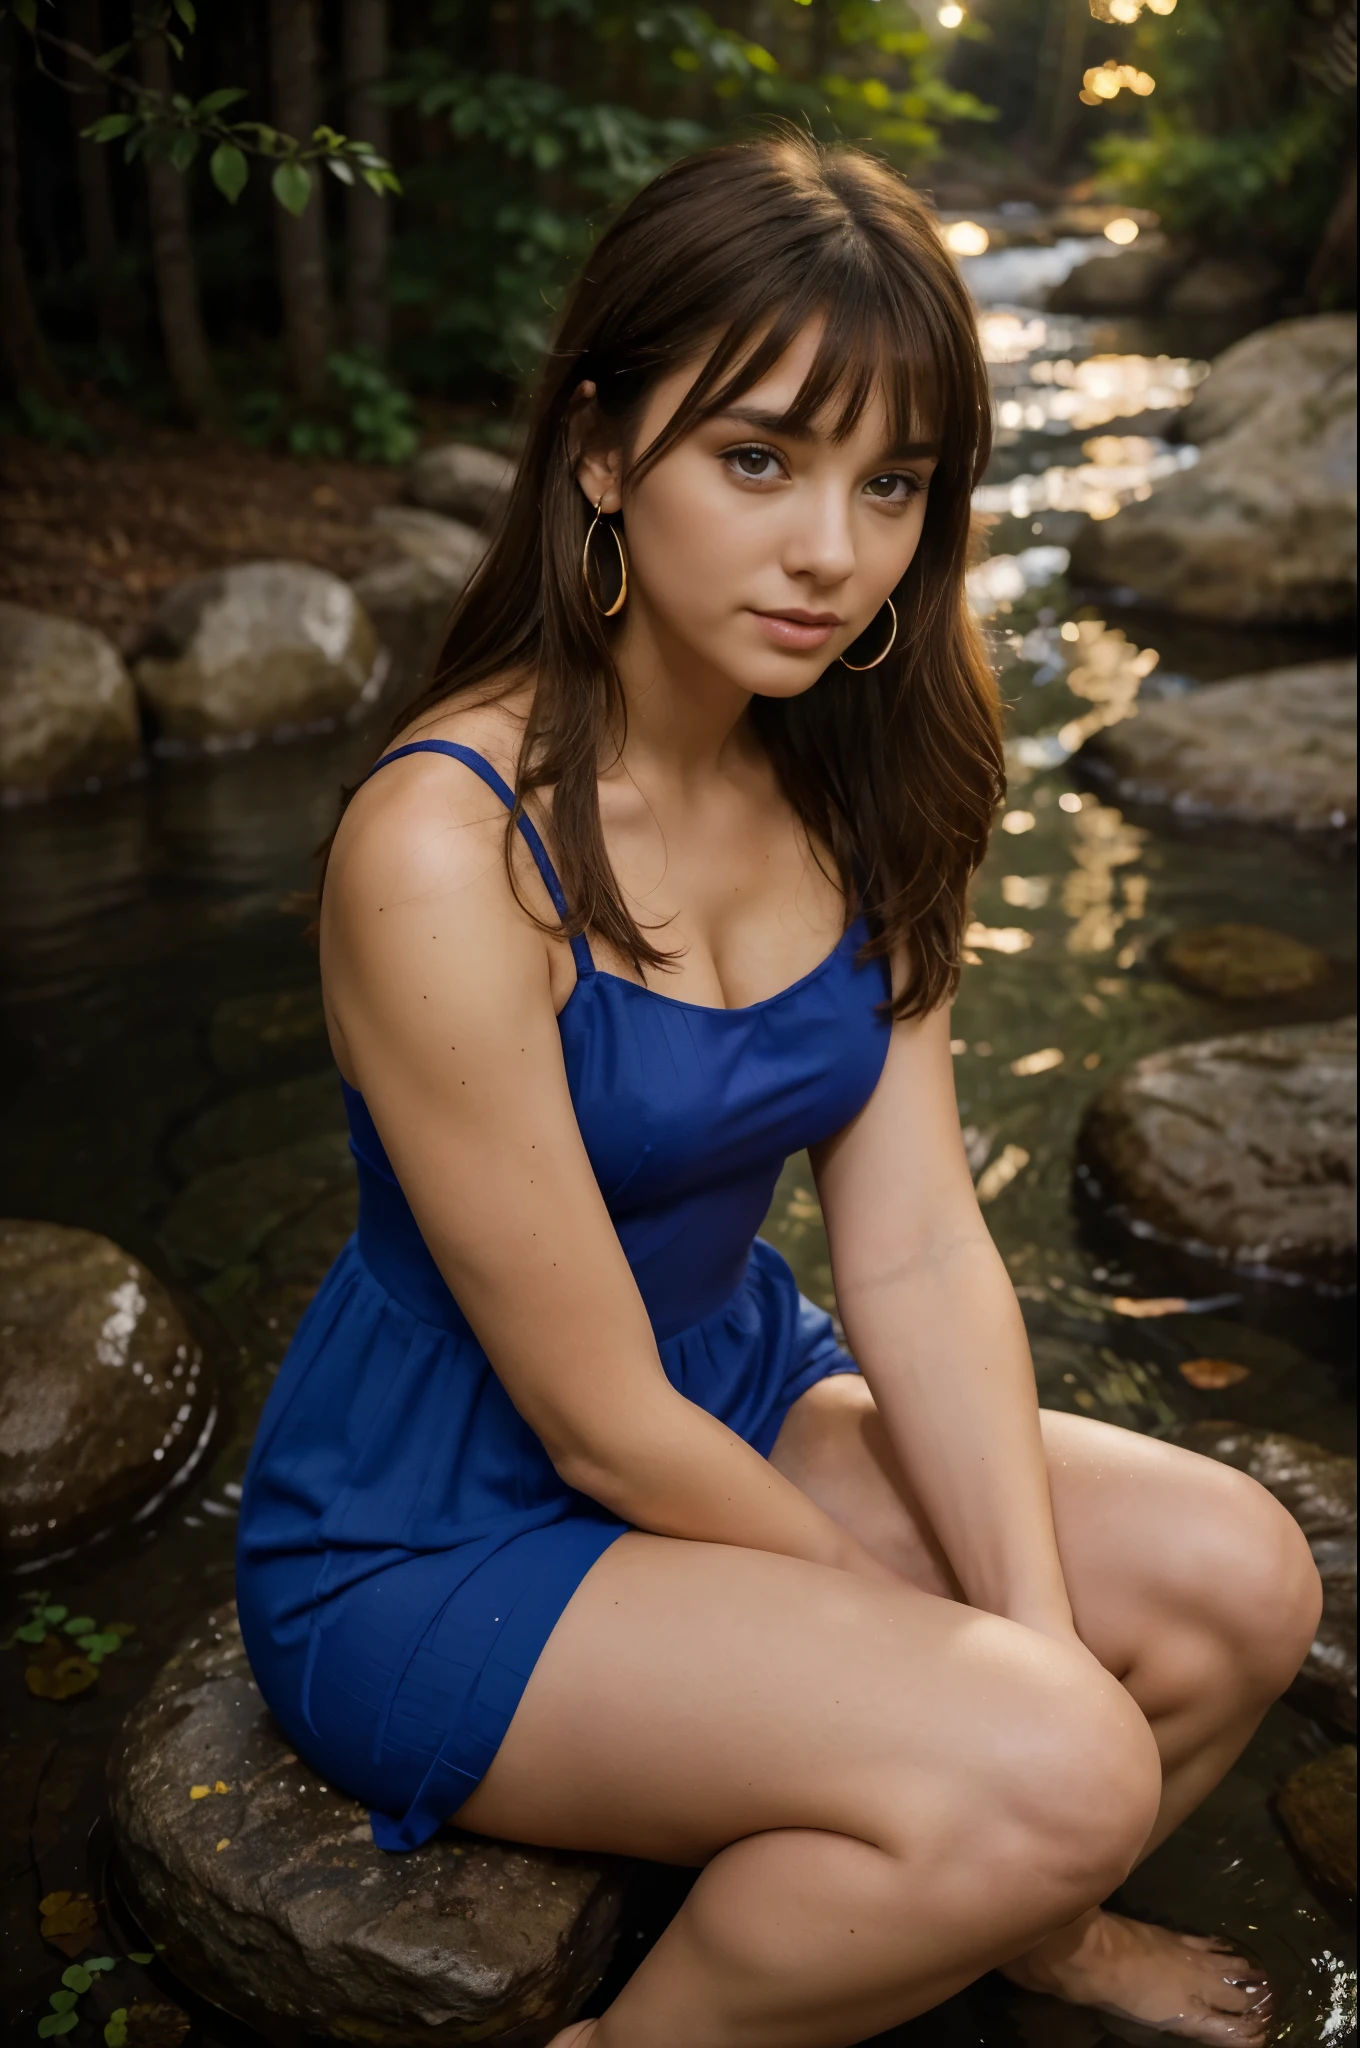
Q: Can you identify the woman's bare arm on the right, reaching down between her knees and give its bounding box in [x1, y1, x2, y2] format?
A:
[813, 1012, 1071, 1634]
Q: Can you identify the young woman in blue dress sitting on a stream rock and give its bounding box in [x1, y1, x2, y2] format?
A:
[240, 139, 1319, 2048]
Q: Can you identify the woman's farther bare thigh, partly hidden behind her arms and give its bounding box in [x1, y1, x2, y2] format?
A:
[770, 1378, 1307, 1677]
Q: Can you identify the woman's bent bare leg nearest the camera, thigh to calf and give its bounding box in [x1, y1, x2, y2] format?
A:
[457, 1532, 1157, 2048]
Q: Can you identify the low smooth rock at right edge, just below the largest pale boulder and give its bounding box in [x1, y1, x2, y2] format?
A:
[1081, 659, 1356, 831]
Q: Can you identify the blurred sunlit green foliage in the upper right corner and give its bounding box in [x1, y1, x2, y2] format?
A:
[1094, 0, 1354, 260]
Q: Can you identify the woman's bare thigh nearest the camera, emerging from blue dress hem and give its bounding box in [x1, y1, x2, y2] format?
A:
[455, 1530, 1137, 1864]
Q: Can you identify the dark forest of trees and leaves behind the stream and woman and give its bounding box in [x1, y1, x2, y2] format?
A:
[0, 0, 1356, 463]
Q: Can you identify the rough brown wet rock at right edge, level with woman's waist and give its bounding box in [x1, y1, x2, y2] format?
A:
[1081, 1018, 1356, 1290]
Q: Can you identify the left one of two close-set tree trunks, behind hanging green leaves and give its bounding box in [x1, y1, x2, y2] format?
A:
[268, 0, 330, 403]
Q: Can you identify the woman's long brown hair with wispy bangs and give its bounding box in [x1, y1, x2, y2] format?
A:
[372, 135, 1004, 1016]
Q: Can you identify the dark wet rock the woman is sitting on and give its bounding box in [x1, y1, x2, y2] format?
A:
[109, 1610, 621, 2048]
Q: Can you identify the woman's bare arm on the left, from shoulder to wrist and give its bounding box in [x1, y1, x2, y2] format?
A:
[322, 756, 885, 1577]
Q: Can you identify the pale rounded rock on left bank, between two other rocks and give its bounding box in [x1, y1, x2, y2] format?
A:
[133, 561, 383, 748]
